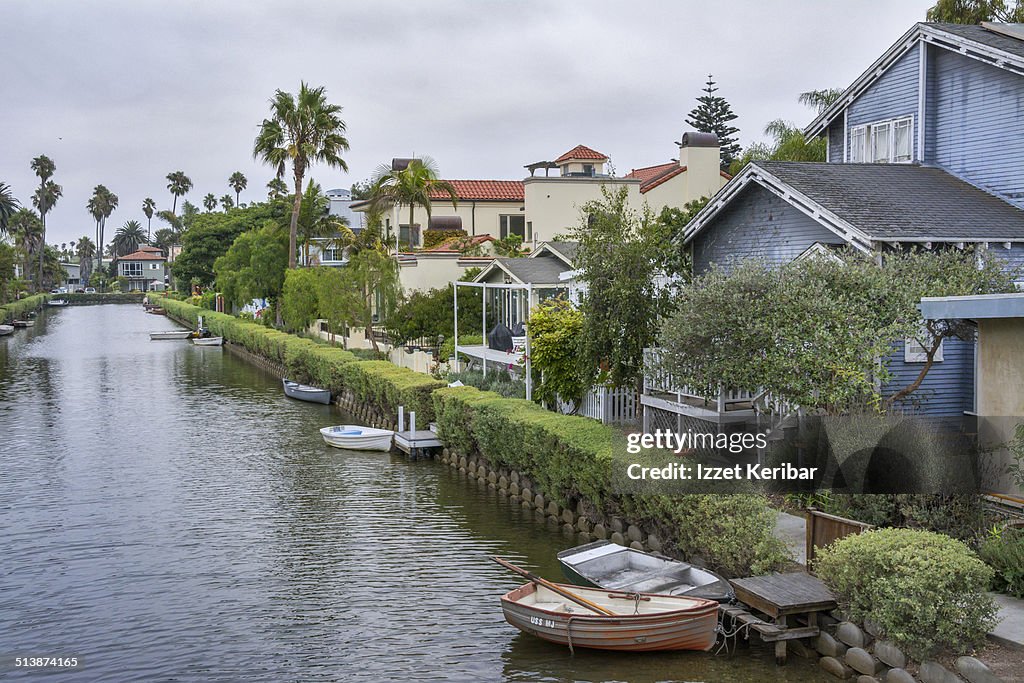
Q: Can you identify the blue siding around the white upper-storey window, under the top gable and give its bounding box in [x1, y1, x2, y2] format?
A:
[836, 44, 921, 160]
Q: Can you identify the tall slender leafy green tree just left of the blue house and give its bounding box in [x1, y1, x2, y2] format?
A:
[571, 187, 671, 387]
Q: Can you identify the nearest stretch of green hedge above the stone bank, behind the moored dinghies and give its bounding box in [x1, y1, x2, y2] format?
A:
[433, 386, 785, 577]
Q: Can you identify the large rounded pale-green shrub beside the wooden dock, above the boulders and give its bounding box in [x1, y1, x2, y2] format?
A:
[815, 528, 995, 658]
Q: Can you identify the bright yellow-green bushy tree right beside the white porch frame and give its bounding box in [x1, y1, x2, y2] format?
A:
[529, 298, 589, 412]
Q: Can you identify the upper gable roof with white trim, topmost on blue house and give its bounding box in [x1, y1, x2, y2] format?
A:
[804, 22, 1024, 137]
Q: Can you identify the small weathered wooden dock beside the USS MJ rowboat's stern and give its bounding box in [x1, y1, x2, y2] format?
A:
[721, 571, 836, 665]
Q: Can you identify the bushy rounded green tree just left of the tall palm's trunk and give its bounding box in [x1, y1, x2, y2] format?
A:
[214, 220, 288, 309]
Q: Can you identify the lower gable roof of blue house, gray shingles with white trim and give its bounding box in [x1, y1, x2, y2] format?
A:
[683, 161, 1024, 251]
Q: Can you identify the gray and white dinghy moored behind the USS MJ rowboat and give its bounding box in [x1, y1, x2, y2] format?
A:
[558, 541, 736, 602]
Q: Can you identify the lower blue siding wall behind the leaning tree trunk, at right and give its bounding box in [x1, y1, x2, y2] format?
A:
[882, 339, 974, 416]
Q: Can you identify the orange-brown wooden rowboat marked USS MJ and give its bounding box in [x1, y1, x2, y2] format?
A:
[502, 584, 718, 652]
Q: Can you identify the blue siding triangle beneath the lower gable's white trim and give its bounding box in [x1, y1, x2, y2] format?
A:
[692, 183, 846, 273]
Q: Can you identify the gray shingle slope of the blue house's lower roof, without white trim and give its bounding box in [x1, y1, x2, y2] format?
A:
[754, 161, 1024, 242]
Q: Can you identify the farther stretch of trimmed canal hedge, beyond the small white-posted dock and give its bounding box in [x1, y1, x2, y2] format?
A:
[158, 298, 444, 424]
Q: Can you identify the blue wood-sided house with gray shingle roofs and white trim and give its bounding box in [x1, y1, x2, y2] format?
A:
[642, 23, 1024, 432]
